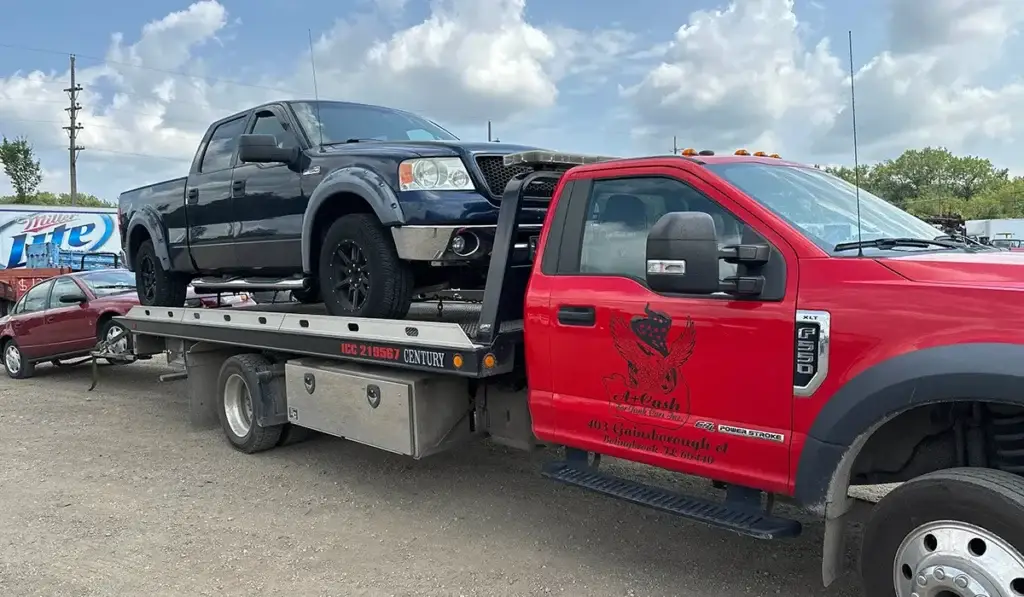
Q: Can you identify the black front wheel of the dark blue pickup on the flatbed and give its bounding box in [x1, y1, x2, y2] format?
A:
[319, 214, 413, 319]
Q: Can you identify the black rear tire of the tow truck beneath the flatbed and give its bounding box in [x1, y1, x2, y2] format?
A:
[217, 354, 285, 454]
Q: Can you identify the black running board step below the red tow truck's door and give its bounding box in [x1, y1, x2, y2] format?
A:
[543, 462, 801, 539]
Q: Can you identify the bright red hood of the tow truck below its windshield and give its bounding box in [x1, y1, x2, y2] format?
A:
[879, 251, 1024, 288]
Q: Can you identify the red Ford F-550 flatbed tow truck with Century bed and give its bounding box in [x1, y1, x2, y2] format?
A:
[96, 152, 1024, 597]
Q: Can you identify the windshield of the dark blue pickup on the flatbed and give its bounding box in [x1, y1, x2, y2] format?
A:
[292, 101, 458, 144]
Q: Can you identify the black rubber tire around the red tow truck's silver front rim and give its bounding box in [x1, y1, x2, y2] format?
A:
[860, 468, 1024, 597]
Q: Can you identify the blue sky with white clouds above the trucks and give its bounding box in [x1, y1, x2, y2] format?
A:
[0, 0, 1024, 199]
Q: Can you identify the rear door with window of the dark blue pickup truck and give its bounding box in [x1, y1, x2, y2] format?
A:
[185, 116, 248, 272]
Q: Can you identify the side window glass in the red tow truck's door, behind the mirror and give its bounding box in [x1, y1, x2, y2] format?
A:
[580, 177, 756, 280]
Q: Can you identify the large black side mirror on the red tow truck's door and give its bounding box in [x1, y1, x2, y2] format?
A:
[647, 212, 771, 296]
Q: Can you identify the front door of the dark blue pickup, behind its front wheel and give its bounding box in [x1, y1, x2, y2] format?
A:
[231, 106, 308, 273]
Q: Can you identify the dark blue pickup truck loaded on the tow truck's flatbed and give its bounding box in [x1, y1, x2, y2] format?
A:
[118, 100, 553, 318]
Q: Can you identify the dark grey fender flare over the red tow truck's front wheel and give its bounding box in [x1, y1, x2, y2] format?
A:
[795, 342, 1024, 514]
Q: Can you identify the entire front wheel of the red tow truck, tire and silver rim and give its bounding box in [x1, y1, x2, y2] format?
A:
[860, 468, 1024, 597]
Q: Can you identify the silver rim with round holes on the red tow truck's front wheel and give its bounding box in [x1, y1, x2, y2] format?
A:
[894, 520, 1024, 597]
